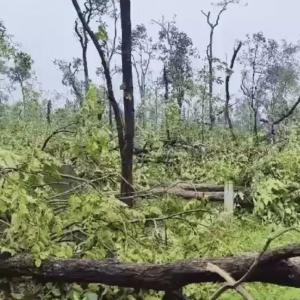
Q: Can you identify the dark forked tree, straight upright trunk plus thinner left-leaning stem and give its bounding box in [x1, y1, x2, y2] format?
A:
[72, 0, 138, 206]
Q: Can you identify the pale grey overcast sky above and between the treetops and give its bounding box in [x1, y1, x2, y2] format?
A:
[0, 0, 300, 102]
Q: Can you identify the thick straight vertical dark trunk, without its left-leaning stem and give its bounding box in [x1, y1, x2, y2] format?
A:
[120, 0, 135, 206]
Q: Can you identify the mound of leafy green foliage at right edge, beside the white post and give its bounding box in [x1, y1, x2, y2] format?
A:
[253, 142, 300, 224]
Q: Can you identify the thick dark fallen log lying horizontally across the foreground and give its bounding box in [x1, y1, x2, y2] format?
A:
[0, 245, 300, 291]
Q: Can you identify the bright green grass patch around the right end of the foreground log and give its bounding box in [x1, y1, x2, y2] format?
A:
[180, 215, 300, 300]
